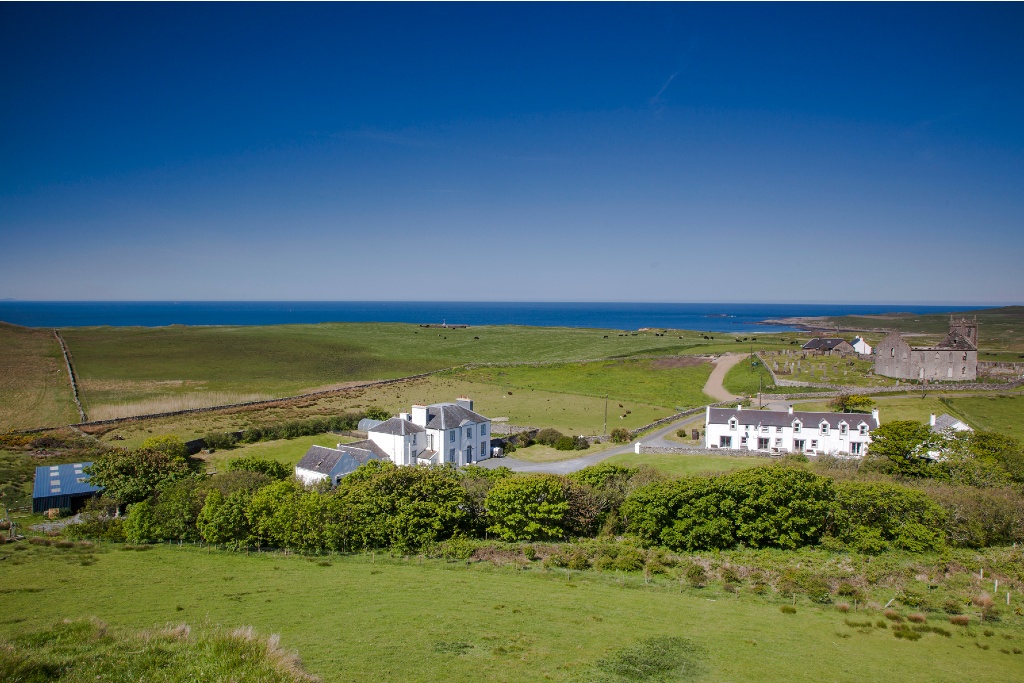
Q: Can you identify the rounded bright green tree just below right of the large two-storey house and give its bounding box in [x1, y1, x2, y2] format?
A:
[485, 474, 569, 541]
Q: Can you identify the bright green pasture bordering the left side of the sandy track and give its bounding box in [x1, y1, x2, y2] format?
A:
[454, 356, 713, 411]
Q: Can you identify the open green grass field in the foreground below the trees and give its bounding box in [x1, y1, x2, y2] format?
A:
[0, 546, 1022, 683]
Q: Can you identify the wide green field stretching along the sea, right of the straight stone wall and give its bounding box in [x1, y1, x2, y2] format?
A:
[51, 323, 788, 418]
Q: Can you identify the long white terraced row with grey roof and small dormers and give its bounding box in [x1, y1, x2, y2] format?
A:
[705, 405, 879, 458]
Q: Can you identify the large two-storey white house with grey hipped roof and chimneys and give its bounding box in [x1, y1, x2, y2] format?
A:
[367, 398, 490, 467]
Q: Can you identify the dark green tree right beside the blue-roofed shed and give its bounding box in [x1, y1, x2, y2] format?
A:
[86, 449, 195, 506]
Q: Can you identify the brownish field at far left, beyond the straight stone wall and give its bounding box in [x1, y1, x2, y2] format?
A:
[0, 323, 79, 431]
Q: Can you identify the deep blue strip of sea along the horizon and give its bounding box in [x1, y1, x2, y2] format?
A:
[0, 301, 981, 334]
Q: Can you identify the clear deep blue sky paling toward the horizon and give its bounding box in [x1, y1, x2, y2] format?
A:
[0, 3, 1024, 303]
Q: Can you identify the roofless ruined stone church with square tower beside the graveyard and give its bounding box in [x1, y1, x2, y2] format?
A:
[874, 315, 978, 382]
